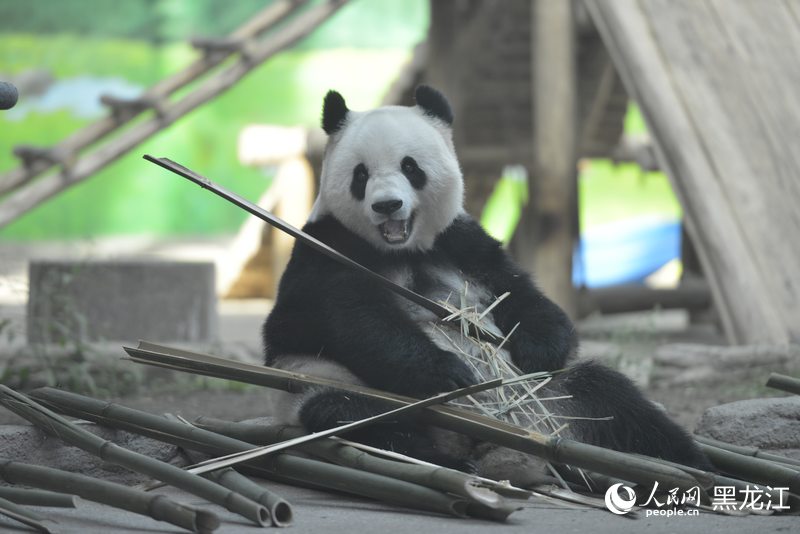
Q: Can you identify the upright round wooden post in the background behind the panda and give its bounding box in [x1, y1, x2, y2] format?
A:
[513, 0, 577, 317]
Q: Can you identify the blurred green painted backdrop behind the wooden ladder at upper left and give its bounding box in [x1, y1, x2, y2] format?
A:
[0, 0, 428, 240]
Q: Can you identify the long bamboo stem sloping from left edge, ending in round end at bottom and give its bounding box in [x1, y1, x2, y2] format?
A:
[0, 385, 269, 526]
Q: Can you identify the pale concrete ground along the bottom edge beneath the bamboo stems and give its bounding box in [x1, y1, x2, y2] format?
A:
[0, 482, 798, 534]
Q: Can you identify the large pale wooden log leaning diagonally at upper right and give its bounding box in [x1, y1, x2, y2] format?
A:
[586, 0, 800, 343]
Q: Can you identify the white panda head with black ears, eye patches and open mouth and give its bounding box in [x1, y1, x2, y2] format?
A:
[311, 86, 464, 251]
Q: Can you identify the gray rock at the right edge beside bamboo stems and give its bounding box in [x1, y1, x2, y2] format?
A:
[695, 395, 800, 460]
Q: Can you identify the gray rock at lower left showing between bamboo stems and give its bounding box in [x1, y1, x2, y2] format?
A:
[0, 424, 188, 486]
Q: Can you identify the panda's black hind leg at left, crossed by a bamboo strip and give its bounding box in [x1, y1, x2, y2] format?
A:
[299, 390, 476, 473]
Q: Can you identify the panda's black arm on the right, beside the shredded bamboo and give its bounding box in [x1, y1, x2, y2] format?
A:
[439, 216, 577, 372]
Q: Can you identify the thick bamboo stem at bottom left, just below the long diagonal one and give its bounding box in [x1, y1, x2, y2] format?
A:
[0, 458, 219, 532]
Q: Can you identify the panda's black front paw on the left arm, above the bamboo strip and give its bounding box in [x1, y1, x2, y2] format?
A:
[401, 350, 478, 397]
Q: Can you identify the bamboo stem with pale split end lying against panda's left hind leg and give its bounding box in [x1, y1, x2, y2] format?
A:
[195, 417, 513, 507]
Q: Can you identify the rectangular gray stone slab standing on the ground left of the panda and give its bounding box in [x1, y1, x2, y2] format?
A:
[27, 261, 218, 343]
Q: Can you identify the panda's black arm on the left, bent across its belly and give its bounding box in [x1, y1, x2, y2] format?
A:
[264, 243, 475, 397]
